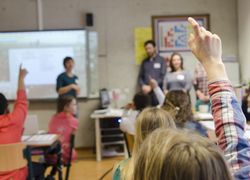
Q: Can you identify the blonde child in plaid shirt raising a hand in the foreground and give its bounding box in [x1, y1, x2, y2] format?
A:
[133, 18, 250, 180]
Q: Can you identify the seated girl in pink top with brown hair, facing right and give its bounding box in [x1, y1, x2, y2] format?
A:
[45, 95, 79, 163]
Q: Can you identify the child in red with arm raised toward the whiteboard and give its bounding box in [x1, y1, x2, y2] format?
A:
[0, 66, 45, 180]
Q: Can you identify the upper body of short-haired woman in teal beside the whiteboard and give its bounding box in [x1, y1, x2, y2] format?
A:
[56, 57, 81, 98]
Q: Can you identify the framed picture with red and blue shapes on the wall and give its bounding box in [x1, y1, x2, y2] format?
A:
[152, 14, 209, 54]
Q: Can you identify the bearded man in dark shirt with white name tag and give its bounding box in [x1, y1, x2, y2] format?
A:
[138, 40, 167, 106]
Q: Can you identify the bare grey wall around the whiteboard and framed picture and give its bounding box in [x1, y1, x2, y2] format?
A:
[0, 0, 237, 147]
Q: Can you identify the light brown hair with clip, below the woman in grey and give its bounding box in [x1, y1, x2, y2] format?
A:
[161, 90, 193, 127]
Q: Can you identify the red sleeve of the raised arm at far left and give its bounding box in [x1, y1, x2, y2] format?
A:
[11, 89, 28, 124]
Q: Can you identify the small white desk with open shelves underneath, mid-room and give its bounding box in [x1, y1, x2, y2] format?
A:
[90, 109, 128, 162]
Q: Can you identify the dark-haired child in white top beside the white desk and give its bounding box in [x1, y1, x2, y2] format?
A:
[120, 92, 151, 135]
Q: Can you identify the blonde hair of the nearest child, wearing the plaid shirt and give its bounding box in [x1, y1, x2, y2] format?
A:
[132, 129, 234, 180]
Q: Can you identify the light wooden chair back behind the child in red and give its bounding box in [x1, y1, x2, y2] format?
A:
[0, 143, 33, 180]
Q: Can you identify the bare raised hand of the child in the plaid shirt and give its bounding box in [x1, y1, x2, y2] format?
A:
[188, 17, 227, 80]
